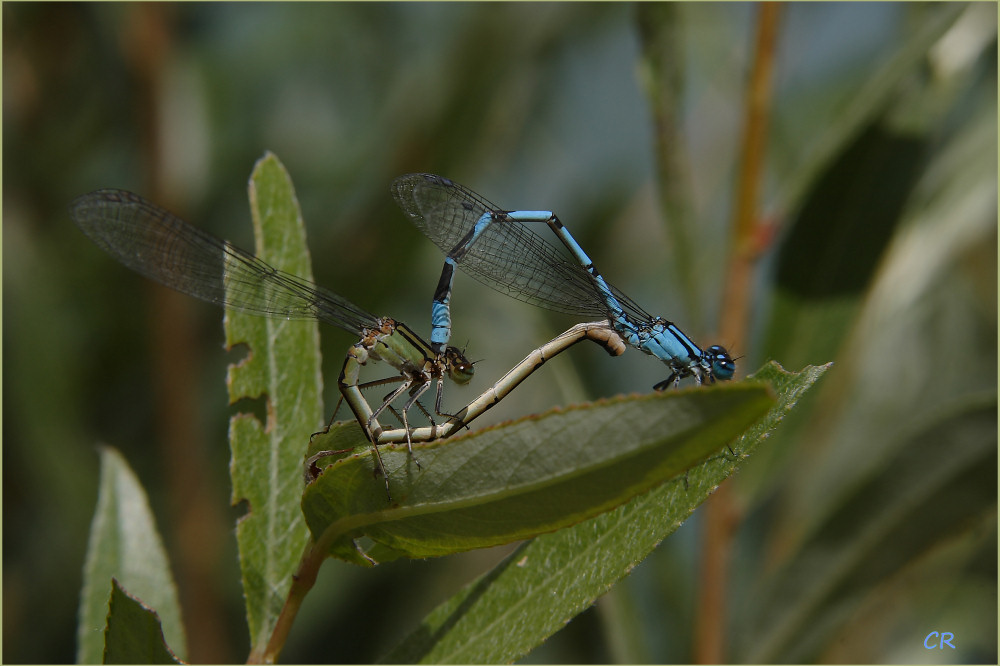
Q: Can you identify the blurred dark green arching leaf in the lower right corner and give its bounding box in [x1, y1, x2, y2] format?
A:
[740, 395, 997, 663]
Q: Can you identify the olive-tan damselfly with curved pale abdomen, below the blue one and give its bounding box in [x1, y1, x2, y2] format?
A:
[70, 189, 625, 497]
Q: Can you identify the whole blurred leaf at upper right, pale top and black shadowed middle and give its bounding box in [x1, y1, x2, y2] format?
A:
[762, 4, 966, 374]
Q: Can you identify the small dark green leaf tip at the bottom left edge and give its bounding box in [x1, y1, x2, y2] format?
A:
[105, 579, 182, 664]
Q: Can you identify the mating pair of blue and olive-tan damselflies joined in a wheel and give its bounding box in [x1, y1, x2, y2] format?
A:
[70, 174, 735, 497]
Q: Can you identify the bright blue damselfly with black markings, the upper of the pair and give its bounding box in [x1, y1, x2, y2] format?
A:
[392, 174, 736, 390]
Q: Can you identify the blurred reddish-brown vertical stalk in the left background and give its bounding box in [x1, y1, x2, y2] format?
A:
[122, 3, 228, 663]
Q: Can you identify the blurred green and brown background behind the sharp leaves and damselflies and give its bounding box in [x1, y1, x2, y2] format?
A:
[2, 3, 997, 663]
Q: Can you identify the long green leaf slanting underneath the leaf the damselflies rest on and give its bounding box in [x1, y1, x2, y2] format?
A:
[384, 363, 828, 663]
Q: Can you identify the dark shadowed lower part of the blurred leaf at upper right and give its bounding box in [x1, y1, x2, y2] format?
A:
[764, 119, 926, 365]
